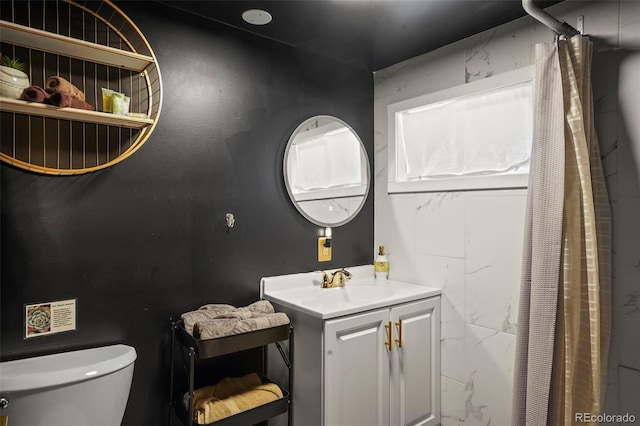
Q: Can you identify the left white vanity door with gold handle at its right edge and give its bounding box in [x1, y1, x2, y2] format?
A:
[323, 309, 390, 426]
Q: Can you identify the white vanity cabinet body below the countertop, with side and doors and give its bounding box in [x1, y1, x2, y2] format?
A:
[268, 294, 440, 426]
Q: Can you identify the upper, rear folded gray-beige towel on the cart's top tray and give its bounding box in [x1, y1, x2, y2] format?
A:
[182, 300, 275, 336]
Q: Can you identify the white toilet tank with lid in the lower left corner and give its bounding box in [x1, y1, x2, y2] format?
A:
[0, 345, 136, 426]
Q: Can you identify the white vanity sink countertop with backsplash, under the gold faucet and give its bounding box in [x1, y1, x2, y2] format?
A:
[260, 265, 440, 319]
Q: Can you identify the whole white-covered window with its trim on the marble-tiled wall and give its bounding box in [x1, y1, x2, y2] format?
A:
[388, 67, 534, 193]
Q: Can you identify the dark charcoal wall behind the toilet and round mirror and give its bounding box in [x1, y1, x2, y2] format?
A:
[1, 2, 373, 425]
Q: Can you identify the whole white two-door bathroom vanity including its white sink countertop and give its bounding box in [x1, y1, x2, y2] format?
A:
[260, 265, 440, 426]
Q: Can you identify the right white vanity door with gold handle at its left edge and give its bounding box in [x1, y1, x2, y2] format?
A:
[390, 297, 440, 426]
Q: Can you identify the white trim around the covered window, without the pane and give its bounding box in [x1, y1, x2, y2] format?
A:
[387, 65, 535, 194]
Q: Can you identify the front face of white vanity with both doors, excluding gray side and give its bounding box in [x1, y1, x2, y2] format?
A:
[324, 297, 440, 426]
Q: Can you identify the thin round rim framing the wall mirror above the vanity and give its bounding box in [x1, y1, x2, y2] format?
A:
[282, 114, 371, 227]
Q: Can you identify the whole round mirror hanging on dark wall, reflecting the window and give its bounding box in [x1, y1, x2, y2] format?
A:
[283, 115, 369, 226]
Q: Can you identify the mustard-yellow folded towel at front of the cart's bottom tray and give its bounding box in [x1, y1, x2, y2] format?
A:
[194, 383, 283, 424]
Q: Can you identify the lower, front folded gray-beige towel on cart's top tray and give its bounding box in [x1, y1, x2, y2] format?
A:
[193, 312, 289, 340]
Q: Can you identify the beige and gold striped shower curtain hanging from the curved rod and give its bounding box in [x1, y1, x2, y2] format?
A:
[512, 36, 611, 426]
